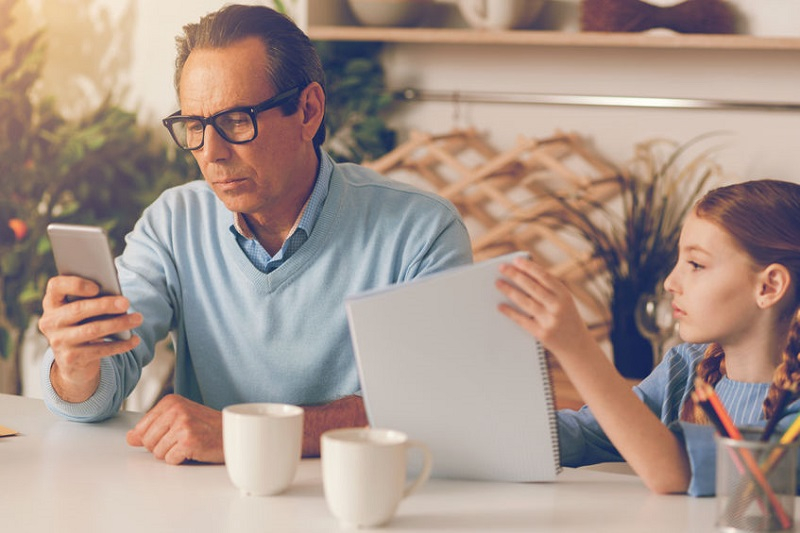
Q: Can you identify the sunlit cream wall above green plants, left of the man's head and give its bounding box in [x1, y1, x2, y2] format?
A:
[15, 0, 271, 121]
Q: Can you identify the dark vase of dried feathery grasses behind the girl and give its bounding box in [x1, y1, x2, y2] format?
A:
[551, 134, 721, 378]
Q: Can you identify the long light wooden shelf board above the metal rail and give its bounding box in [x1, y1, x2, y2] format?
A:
[308, 26, 800, 51]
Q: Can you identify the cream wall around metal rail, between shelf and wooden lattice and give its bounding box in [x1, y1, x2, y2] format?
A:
[386, 41, 800, 181]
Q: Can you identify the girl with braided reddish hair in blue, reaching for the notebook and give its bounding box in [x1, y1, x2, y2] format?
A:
[497, 180, 800, 496]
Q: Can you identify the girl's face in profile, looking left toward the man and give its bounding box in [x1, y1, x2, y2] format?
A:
[664, 213, 760, 346]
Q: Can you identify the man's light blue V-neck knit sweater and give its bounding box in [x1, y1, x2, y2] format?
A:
[42, 154, 472, 421]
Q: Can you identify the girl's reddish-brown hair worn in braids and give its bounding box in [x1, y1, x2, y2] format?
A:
[681, 180, 800, 423]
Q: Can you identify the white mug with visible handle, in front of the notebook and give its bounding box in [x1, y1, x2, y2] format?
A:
[322, 428, 433, 527]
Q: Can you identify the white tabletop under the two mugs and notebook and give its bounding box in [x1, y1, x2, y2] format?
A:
[0, 394, 764, 533]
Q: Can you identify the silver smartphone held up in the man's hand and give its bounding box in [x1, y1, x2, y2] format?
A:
[47, 223, 131, 340]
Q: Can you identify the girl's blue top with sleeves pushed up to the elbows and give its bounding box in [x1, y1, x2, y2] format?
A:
[558, 344, 800, 496]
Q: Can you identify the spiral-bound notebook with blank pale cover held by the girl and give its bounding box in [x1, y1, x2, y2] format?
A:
[345, 252, 561, 482]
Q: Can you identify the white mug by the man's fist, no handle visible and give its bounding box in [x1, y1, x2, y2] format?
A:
[222, 403, 303, 496]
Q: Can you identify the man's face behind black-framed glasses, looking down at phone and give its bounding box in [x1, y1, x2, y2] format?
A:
[179, 37, 315, 217]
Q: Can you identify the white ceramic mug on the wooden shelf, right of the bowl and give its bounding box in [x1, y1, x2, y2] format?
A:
[458, 0, 544, 30]
